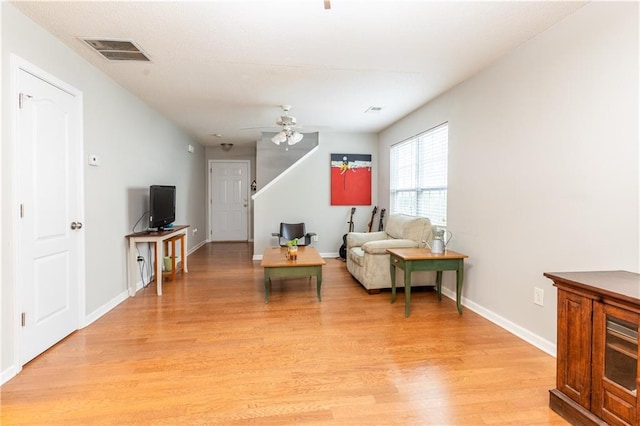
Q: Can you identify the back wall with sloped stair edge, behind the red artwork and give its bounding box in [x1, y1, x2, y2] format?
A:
[253, 133, 378, 256]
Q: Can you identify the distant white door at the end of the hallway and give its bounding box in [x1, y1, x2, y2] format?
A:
[209, 161, 249, 241]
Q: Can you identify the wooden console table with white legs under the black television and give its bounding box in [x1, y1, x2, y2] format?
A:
[126, 225, 189, 297]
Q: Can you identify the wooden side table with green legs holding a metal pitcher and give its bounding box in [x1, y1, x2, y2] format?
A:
[387, 248, 469, 318]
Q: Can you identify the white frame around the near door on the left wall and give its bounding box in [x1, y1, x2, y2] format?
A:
[9, 54, 86, 379]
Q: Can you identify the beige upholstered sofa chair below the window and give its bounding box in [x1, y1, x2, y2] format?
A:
[347, 214, 436, 293]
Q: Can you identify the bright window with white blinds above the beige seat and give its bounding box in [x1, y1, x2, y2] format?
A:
[390, 123, 449, 226]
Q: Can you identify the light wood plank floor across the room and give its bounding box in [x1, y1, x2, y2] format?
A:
[0, 243, 566, 425]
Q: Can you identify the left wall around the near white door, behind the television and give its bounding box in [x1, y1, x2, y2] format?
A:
[0, 2, 206, 381]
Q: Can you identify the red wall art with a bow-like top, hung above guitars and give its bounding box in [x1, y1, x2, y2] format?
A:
[331, 154, 371, 206]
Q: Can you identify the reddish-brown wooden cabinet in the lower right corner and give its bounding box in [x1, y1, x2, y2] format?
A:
[544, 271, 640, 425]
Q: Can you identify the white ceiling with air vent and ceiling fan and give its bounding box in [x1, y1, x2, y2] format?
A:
[14, 0, 584, 145]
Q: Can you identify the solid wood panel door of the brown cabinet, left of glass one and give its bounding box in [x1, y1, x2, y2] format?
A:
[556, 289, 593, 410]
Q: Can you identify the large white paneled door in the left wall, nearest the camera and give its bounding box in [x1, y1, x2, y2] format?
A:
[17, 68, 84, 365]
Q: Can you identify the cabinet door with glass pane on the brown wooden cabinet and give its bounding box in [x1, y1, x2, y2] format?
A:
[592, 302, 640, 425]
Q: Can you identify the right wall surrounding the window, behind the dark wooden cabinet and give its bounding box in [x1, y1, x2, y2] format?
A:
[379, 2, 640, 351]
